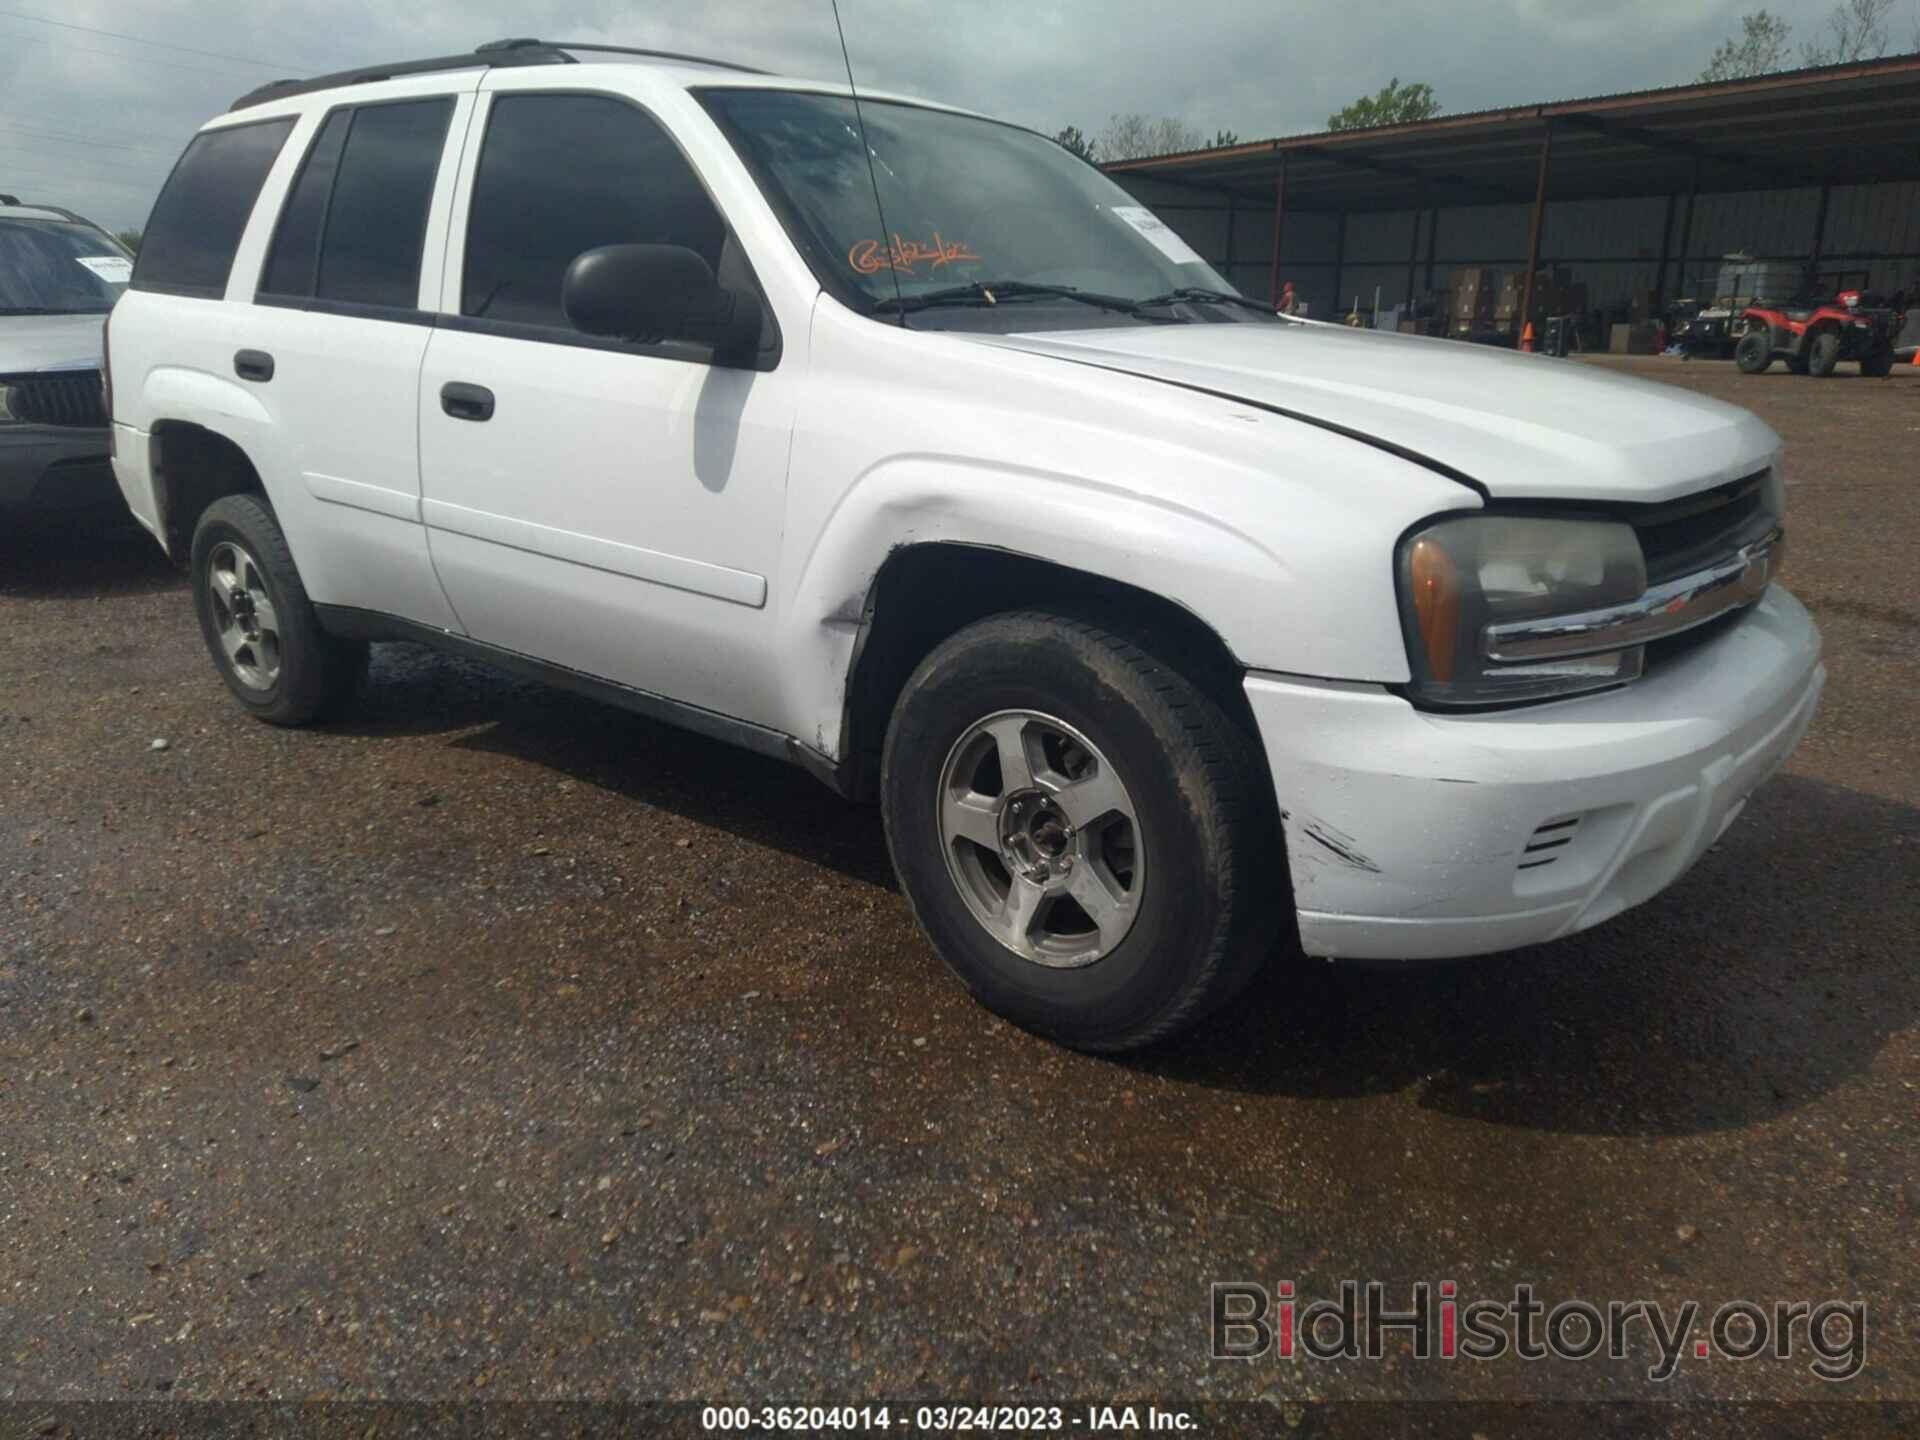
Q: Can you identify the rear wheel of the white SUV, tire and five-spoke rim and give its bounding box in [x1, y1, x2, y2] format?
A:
[192, 495, 367, 726]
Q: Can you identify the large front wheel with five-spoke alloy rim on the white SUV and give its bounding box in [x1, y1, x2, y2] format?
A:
[881, 611, 1292, 1052]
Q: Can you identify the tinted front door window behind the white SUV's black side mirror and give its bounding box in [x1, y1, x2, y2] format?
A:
[461, 94, 728, 330]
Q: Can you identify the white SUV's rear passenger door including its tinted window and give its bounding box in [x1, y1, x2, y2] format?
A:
[234, 79, 474, 630]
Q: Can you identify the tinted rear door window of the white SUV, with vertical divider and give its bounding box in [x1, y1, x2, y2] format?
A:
[259, 100, 453, 309]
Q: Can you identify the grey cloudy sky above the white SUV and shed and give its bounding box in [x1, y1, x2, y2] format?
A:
[0, 0, 1920, 228]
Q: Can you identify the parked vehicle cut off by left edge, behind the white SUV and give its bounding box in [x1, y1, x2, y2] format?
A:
[0, 196, 132, 513]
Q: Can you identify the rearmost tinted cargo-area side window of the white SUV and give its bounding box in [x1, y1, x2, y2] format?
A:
[132, 117, 294, 298]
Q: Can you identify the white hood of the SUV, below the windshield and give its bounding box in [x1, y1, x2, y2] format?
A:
[979, 321, 1780, 501]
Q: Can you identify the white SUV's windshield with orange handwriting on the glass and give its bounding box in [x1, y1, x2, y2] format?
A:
[701, 88, 1271, 328]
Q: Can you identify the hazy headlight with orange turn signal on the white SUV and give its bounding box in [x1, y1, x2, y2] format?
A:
[1400, 515, 1647, 705]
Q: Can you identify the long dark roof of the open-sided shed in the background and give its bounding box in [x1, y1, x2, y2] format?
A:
[1106, 54, 1920, 211]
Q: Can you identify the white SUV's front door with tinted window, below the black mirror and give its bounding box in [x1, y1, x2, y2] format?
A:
[420, 69, 799, 724]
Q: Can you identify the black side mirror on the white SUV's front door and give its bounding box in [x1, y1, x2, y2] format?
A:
[561, 246, 760, 365]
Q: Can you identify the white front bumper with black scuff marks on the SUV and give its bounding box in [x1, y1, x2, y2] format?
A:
[1246, 586, 1826, 960]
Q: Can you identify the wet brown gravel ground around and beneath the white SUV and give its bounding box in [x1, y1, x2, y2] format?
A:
[0, 361, 1920, 1415]
